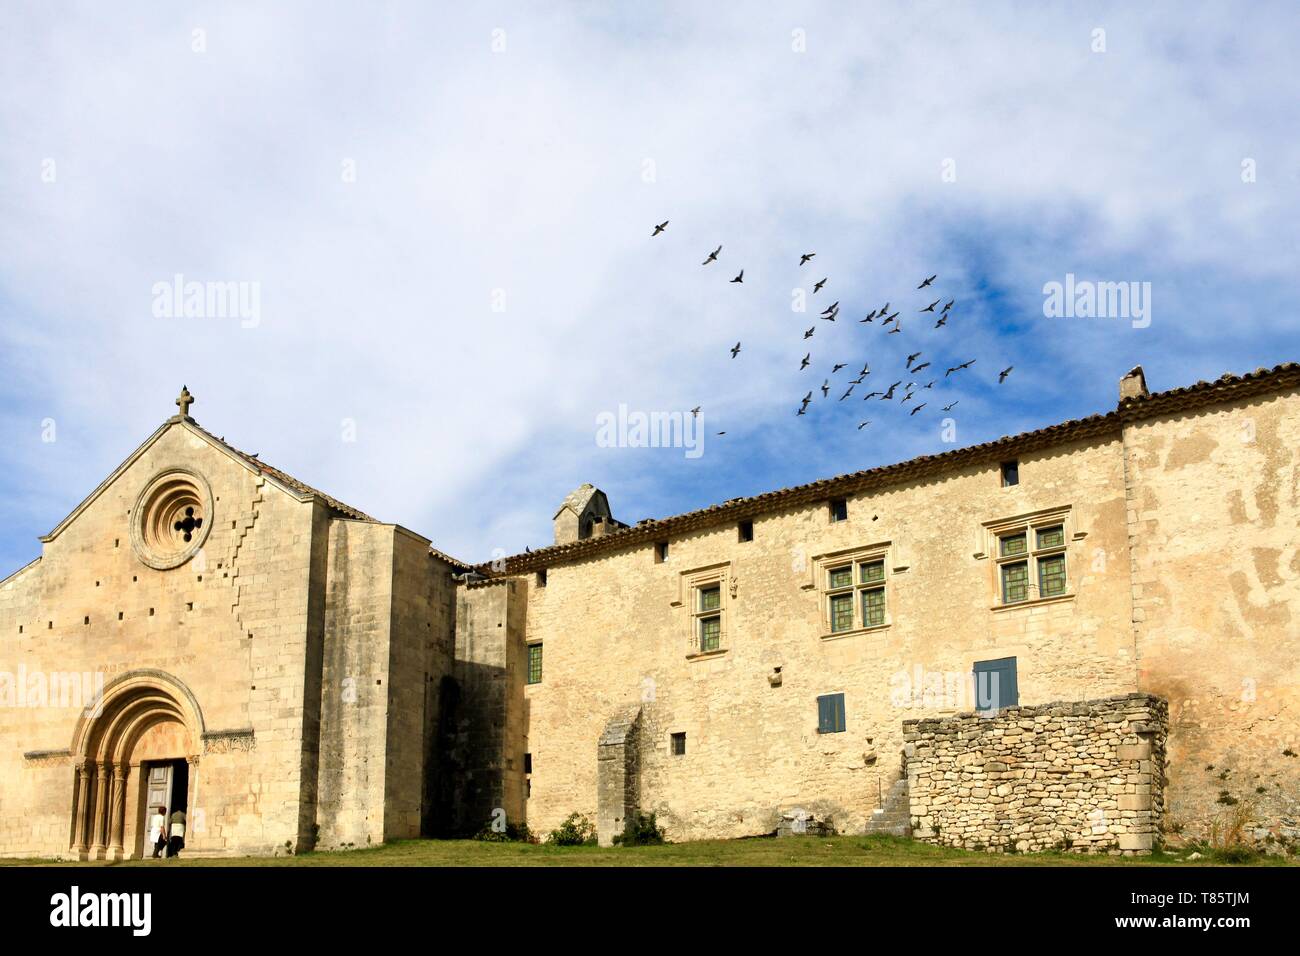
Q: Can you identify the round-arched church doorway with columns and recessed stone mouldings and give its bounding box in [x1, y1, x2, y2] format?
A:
[70, 671, 203, 860]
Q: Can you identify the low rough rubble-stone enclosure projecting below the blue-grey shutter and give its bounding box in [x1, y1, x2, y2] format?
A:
[904, 693, 1169, 855]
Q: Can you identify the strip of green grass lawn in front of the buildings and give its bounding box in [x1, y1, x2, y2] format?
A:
[0, 836, 1300, 866]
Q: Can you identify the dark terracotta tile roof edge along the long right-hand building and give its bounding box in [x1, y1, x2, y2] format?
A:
[476, 362, 1300, 576]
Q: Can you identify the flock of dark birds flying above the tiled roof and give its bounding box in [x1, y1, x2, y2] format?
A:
[651, 220, 1014, 434]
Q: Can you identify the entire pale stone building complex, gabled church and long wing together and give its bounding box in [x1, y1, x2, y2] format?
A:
[0, 364, 1300, 858]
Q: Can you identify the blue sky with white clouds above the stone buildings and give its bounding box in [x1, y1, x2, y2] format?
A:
[0, 3, 1300, 574]
